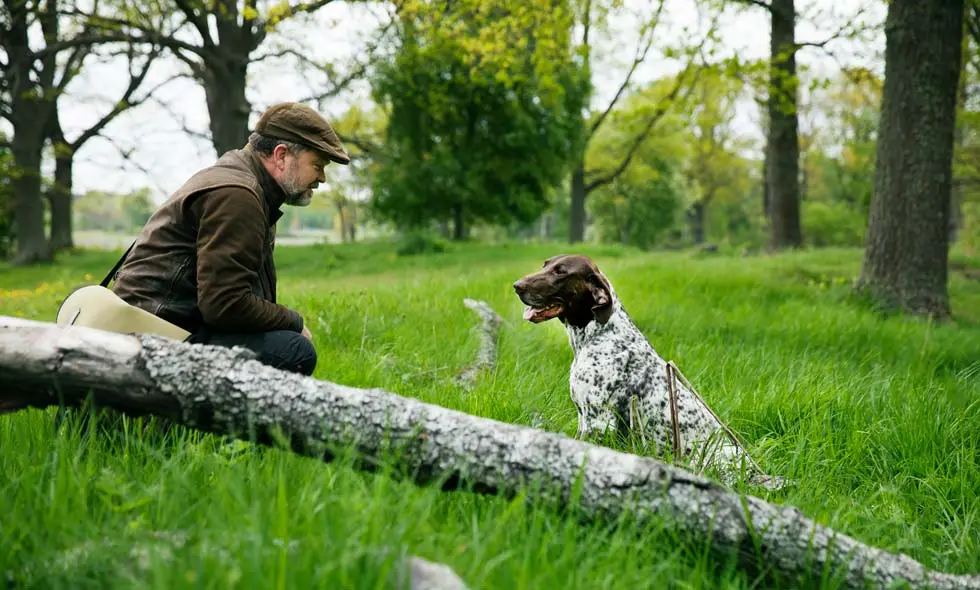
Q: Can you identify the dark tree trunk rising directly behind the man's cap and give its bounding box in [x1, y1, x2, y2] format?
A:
[203, 59, 252, 157]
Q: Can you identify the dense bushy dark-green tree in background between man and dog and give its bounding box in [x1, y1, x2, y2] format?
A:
[372, 0, 584, 239]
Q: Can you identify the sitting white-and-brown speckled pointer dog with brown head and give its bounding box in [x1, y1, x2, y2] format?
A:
[514, 255, 784, 488]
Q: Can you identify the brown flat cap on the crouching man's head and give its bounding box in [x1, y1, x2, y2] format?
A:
[255, 102, 350, 165]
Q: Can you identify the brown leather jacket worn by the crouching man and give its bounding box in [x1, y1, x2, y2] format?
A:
[112, 146, 303, 334]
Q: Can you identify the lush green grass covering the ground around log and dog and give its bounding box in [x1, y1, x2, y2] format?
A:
[0, 244, 980, 589]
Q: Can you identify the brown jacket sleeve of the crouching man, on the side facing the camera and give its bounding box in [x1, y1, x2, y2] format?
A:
[194, 187, 303, 332]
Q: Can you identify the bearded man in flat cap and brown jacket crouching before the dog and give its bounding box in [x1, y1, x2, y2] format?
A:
[112, 102, 350, 375]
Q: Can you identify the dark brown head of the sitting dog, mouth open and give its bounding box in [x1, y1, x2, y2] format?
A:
[514, 254, 613, 327]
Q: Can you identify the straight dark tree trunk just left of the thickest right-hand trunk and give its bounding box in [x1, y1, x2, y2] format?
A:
[767, 0, 803, 250]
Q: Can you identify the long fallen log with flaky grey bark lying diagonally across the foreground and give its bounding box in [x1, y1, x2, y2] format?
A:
[0, 317, 980, 589]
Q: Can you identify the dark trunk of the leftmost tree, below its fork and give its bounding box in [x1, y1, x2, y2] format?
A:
[11, 132, 51, 265]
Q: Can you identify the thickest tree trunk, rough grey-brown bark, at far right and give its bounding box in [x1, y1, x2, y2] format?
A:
[858, 0, 964, 318]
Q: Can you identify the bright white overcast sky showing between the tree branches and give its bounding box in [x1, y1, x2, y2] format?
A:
[5, 0, 884, 202]
